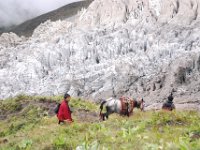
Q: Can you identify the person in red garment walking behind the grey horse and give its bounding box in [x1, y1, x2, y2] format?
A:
[57, 93, 73, 124]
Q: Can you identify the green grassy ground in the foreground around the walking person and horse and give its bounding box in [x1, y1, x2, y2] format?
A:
[0, 96, 200, 150]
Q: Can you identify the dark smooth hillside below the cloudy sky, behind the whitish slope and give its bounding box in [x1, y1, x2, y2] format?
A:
[0, 0, 93, 36]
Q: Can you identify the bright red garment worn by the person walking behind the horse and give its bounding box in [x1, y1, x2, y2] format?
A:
[57, 100, 72, 121]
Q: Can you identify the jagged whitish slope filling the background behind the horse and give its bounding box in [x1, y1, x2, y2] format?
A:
[0, 0, 200, 109]
